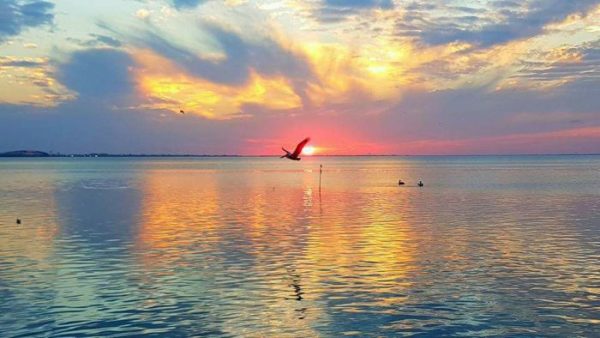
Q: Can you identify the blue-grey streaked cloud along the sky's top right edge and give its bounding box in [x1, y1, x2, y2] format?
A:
[398, 0, 600, 47]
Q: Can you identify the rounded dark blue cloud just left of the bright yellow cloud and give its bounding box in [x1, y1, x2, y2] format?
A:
[57, 49, 134, 99]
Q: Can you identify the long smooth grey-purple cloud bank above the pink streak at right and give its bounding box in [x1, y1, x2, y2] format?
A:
[371, 80, 600, 145]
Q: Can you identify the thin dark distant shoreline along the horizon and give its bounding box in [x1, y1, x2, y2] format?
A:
[0, 150, 600, 158]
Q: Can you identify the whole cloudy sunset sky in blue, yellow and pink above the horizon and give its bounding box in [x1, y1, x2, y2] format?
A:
[0, 0, 600, 155]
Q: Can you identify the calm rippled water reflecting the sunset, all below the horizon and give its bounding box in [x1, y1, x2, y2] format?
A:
[0, 156, 600, 337]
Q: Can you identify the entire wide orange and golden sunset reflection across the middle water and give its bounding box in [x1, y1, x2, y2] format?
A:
[136, 165, 415, 335]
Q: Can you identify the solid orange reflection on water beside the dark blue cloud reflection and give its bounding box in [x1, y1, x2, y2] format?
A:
[136, 171, 222, 267]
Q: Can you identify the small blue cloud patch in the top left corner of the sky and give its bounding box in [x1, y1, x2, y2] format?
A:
[0, 0, 54, 42]
